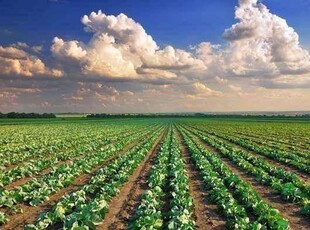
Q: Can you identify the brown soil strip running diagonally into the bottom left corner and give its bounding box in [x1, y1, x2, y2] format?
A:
[1, 129, 162, 230]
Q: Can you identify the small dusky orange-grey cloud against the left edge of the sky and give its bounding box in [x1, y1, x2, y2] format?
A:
[0, 43, 63, 77]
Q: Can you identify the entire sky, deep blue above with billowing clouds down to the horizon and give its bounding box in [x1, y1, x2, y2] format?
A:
[0, 0, 310, 113]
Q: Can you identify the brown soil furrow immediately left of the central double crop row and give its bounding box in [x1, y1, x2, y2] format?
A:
[96, 128, 167, 230]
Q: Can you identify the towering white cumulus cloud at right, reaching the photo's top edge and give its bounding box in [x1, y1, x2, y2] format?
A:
[223, 0, 310, 77]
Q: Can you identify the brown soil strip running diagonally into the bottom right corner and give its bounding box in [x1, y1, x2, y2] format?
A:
[200, 135, 310, 230]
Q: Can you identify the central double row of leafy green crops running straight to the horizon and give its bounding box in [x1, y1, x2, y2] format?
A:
[129, 130, 195, 229]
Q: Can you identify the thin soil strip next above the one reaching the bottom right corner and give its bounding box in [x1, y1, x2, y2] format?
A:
[199, 129, 310, 185]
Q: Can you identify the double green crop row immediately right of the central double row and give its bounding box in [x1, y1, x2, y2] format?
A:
[178, 126, 288, 229]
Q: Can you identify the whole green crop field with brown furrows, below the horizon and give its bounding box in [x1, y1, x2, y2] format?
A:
[0, 118, 310, 230]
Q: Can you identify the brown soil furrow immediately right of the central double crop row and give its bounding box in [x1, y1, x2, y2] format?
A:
[178, 130, 226, 230]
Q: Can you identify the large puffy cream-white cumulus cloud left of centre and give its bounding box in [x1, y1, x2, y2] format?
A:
[51, 11, 205, 78]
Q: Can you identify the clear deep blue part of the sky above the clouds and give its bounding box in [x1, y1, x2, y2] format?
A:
[0, 0, 310, 48]
